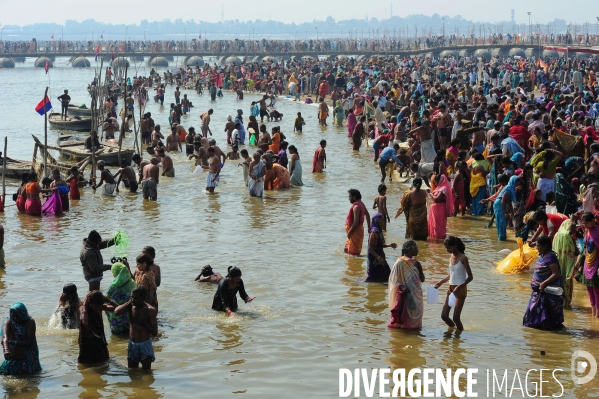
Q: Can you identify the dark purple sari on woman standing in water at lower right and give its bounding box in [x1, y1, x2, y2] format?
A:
[522, 252, 564, 330]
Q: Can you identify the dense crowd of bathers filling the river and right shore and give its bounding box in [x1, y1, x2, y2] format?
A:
[5, 45, 599, 374]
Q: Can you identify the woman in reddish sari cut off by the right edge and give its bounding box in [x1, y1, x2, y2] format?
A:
[573, 212, 599, 317]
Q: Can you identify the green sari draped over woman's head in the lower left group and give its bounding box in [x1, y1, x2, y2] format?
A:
[106, 262, 135, 334]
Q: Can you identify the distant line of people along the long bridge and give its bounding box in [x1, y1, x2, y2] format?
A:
[0, 31, 599, 54]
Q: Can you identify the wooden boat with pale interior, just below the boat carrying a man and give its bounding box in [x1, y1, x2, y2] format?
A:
[53, 134, 135, 166]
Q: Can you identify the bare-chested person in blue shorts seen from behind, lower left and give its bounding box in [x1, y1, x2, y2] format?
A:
[114, 285, 158, 370]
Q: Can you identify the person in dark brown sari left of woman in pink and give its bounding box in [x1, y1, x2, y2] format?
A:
[395, 177, 428, 241]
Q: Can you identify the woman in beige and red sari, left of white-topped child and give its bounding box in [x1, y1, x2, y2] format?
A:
[387, 240, 424, 329]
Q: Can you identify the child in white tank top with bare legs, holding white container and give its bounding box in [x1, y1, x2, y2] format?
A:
[435, 236, 473, 330]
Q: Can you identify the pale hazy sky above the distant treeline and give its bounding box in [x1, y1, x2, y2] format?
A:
[0, 0, 599, 26]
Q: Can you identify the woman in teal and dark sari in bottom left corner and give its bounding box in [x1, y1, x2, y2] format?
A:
[0, 302, 42, 375]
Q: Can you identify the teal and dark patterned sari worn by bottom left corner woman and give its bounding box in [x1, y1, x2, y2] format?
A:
[0, 302, 42, 375]
